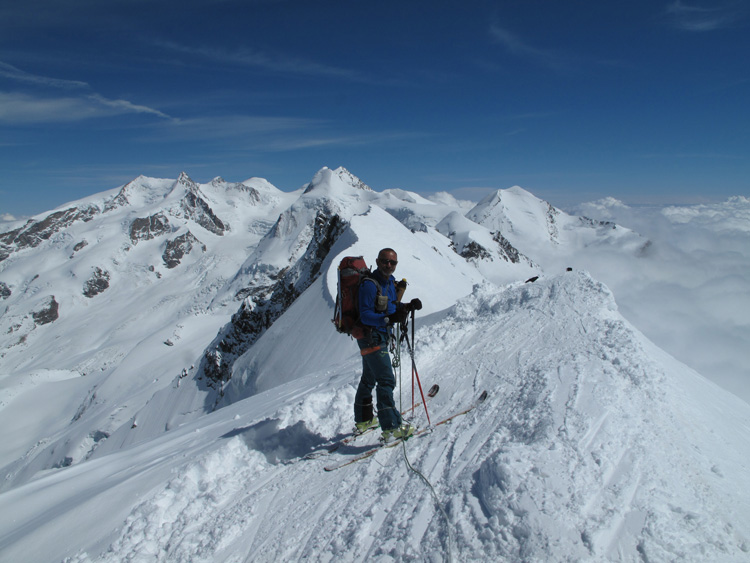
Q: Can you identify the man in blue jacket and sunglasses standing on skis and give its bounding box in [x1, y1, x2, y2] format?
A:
[354, 248, 422, 443]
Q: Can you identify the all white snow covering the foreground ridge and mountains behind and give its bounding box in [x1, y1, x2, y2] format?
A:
[0, 168, 750, 562]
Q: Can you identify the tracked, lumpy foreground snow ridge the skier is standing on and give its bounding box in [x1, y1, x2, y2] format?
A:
[0, 272, 750, 562]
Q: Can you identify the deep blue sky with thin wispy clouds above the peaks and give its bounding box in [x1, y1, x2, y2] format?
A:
[0, 0, 750, 217]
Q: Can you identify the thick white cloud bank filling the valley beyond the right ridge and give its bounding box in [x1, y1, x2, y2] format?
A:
[575, 196, 750, 402]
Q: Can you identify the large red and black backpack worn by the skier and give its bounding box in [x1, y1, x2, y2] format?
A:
[332, 256, 382, 339]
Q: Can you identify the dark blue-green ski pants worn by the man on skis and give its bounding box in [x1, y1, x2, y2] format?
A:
[354, 330, 401, 430]
